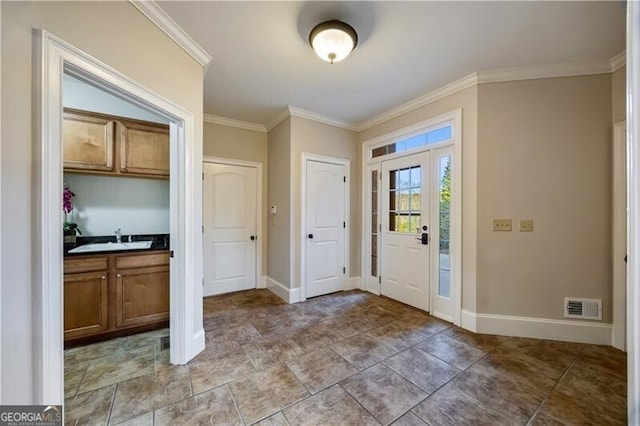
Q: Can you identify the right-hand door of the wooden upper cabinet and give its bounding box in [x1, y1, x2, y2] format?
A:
[118, 121, 169, 176]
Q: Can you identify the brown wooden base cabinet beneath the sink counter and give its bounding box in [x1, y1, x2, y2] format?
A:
[64, 251, 170, 341]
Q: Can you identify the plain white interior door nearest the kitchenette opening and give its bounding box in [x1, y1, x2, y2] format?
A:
[203, 163, 257, 296]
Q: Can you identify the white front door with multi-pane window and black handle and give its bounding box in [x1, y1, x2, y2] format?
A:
[379, 152, 431, 310]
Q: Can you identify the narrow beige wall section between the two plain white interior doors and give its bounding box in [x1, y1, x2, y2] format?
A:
[267, 118, 293, 287]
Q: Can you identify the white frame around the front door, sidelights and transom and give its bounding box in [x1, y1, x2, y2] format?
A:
[360, 108, 463, 326]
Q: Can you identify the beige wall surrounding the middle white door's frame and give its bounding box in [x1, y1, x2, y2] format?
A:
[291, 117, 361, 287]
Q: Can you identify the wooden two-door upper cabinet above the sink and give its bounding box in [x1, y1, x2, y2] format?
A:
[62, 109, 169, 178]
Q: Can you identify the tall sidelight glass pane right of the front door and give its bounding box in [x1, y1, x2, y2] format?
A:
[438, 155, 451, 298]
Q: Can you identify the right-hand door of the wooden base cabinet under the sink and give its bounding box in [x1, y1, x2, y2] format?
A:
[116, 266, 169, 327]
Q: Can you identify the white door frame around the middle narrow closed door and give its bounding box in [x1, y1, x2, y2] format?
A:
[300, 152, 351, 302]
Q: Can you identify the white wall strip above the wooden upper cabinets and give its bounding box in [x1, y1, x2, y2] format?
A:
[62, 74, 169, 124]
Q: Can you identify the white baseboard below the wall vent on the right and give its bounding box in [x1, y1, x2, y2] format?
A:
[462, 310, 612, 346]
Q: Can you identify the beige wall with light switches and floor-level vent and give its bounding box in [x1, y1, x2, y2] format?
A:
[477, 74, 612, 322]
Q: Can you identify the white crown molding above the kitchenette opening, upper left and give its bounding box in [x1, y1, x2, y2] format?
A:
[129, 0, 211, 67]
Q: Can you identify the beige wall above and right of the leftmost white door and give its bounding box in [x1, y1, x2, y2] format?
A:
[203, 122, 269, 275]
